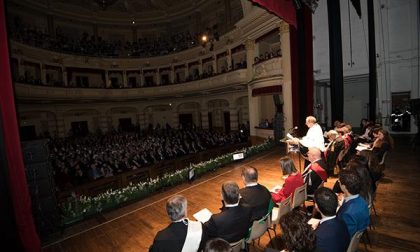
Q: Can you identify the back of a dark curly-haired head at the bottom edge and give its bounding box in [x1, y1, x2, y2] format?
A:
[280, 211, 315, 252]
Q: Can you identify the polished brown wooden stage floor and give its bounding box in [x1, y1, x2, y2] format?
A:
[43, 139, 420, 252]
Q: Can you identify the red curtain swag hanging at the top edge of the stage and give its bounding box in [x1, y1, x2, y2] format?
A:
[251, 0, 297, 27]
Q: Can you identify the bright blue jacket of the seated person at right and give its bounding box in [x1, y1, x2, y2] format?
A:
[337, 196, 370, 238]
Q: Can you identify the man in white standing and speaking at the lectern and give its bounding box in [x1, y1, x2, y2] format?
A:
[289, 116, 325, 151]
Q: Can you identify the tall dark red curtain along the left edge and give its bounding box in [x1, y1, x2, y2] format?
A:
[0, 0, 41, 251]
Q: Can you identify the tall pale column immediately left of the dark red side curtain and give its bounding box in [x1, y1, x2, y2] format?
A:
[280, 21, 293, 129]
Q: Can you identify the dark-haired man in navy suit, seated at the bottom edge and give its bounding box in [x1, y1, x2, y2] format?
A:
[314, 187, 350, 252]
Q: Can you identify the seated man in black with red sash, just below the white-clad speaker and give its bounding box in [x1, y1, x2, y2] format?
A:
[302, 148, 328, 197]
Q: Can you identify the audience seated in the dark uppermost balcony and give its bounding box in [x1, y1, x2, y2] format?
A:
[10, 18, 199, 58]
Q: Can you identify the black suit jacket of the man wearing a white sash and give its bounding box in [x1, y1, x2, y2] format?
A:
[149, 222, 207, 252]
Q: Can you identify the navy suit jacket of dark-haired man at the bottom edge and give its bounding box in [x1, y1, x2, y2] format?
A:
[315, 218, 350, 252]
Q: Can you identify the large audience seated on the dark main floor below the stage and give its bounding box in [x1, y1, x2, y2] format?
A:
[49, 126, 247, 190]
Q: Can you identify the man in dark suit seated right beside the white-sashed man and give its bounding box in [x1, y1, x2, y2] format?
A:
[204, 181, 252, 243]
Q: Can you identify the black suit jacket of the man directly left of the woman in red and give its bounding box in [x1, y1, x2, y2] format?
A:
[239, 184, 271, 220]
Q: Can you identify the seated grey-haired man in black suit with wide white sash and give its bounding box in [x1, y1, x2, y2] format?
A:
[149, 195, 207, 252]
